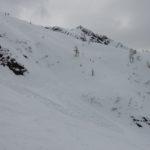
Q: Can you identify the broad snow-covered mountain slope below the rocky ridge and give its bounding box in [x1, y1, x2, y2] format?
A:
[0, 14, 150, 150]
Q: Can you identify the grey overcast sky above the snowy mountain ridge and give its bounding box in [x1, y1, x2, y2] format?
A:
[0, 0, 150, 49]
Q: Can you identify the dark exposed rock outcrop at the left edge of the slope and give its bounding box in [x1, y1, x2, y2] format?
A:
[0, 46, 27, 75]
